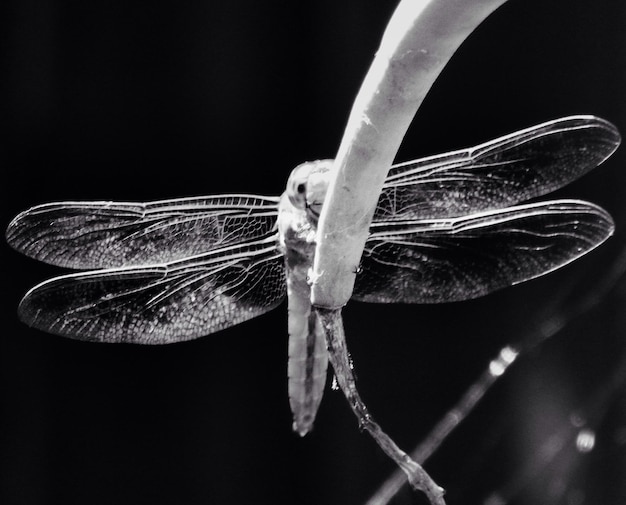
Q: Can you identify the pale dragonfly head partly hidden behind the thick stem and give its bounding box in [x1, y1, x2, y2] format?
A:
[287, 160, 333, 223]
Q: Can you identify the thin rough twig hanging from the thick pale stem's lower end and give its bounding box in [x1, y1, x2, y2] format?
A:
[318, 309, 445, 505]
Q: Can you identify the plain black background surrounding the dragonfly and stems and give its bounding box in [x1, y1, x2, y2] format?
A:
[0, 0, 626, 505]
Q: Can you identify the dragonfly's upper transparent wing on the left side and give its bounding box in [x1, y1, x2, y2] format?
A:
[6, 195, 278, 269]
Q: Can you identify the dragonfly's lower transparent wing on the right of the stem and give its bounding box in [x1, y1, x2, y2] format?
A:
[353, 200, 613, 303]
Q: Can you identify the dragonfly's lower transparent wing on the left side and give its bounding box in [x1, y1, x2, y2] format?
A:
[19, 240, 286, 344]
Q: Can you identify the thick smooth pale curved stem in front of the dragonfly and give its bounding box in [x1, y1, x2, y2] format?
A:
[311, 0, 506, 308]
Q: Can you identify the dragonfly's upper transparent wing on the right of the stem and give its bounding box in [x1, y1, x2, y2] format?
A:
[374, 116, 620, 222]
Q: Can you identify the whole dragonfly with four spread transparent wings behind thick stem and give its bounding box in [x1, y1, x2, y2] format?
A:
[6, 116, 620, 436]
